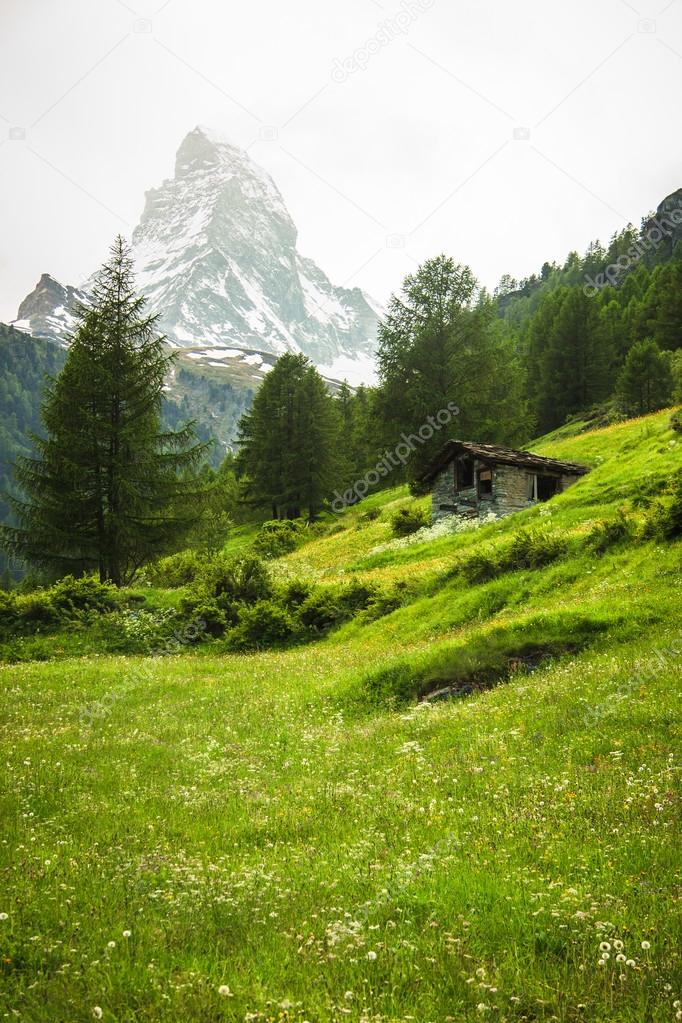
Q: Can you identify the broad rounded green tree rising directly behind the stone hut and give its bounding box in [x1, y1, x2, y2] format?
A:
[376, 256, 528, 479]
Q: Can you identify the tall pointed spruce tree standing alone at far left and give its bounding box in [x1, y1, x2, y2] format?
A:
[2, 236, 207, 586]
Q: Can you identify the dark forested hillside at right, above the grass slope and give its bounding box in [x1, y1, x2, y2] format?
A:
[495, 190, 682, 433]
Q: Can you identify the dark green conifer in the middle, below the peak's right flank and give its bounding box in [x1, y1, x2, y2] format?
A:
[238, 353, 343, 520]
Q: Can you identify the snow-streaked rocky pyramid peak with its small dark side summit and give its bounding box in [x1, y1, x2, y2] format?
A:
[14, 127, 380, 383]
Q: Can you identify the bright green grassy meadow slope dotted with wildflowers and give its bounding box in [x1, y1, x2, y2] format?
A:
[0, 414, 682, 1023]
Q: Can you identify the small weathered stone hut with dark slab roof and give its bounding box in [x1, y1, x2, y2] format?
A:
[421, 441, 589, 522]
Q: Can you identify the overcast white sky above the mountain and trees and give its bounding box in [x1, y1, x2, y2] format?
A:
[0, 0, 682, 320]
